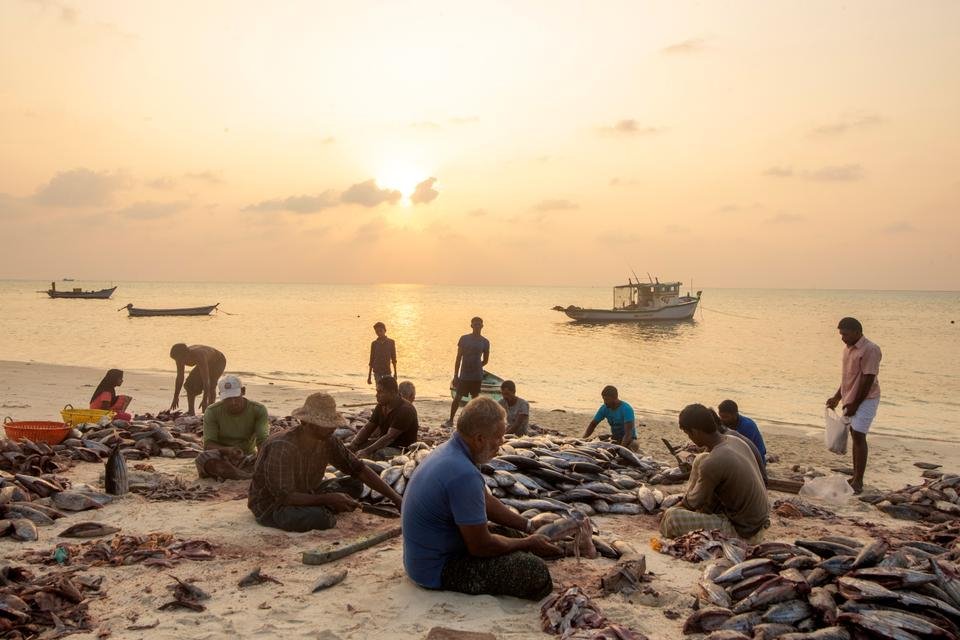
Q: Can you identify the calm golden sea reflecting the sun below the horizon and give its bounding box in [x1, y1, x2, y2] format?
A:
[0, 281, 960, 439]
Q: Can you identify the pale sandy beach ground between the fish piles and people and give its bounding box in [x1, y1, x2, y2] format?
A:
[0, 362, 960, 640]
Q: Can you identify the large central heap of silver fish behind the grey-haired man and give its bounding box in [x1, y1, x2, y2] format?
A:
[361, 435, 681, 518]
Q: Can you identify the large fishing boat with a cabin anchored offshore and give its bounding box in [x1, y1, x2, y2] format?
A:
[553, 278, 703, 322]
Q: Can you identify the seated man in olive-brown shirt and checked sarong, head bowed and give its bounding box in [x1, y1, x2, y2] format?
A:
[660, 404, 770, 543]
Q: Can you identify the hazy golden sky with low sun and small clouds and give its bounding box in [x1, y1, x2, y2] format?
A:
[0, 0, 960, 290]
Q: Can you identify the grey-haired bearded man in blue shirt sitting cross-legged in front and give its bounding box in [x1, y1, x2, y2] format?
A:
[402, 398, 561, 600]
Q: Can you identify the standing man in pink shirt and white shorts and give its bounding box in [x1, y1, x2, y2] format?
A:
[827, 318, 883, 493]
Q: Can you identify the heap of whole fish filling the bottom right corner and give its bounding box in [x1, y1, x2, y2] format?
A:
[683, 536, 960, 640]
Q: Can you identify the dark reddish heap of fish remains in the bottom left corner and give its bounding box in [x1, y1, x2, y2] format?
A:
[0, 566, 103, 640]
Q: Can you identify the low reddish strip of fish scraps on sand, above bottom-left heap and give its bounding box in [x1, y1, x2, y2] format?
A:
[25, 533, 215, 568]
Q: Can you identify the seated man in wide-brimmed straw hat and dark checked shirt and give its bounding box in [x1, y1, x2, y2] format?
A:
[247, 392, 401, 531]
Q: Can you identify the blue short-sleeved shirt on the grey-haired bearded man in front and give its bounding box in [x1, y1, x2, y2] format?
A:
[401, 433, 487, 589]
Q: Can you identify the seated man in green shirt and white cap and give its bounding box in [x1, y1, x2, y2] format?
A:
[194, 376, 270, 480]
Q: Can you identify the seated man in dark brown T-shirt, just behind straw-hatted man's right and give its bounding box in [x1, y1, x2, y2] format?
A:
[349, 376, 420, 459]
